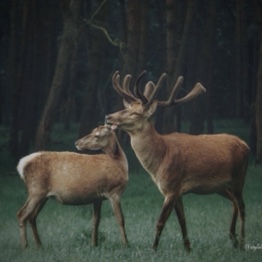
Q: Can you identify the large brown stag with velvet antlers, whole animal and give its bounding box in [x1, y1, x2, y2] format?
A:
[106, 72, 249, 251]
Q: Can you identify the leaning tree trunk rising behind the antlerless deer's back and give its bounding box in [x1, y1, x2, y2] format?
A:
[35, 0, 83, 150]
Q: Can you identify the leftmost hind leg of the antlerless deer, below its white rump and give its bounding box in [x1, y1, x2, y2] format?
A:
[17, 197, 41, 248]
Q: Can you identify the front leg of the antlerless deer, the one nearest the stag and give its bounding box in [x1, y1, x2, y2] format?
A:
[110, 196, 128, 245]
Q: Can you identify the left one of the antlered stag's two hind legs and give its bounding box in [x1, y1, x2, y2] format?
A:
[219, 190, 238, 247]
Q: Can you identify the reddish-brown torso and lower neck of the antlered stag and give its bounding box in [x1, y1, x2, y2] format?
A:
[130, 127, 248, 195]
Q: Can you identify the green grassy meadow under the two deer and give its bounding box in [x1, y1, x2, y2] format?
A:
[0, 121, 262, 262]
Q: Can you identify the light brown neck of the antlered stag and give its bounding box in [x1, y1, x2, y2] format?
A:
[129, 122, 165, 179]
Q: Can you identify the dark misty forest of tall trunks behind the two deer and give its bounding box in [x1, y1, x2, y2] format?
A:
[0, 0, 262, 163]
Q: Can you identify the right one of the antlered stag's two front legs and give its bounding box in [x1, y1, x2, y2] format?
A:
[174, 198, 190, 251]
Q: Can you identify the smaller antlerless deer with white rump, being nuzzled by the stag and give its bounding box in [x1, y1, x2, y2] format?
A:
[17, 125, 128, 247]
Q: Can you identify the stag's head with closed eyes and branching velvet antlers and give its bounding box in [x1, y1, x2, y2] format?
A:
[106, 71, 206, 131]
